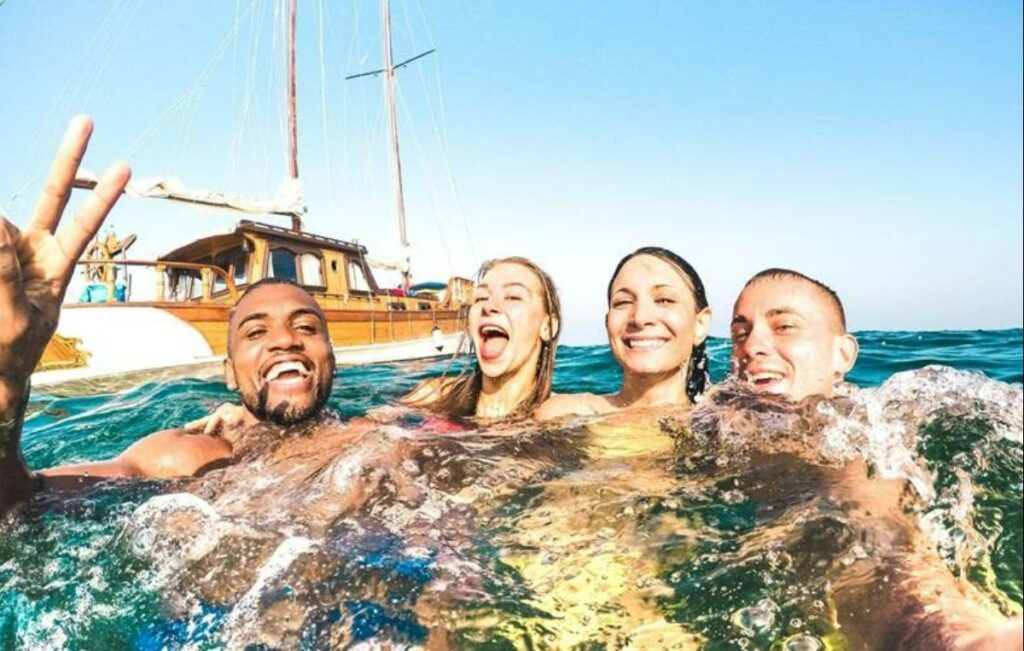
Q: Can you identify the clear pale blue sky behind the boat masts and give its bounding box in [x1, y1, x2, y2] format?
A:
[0, 0, 1024, 344]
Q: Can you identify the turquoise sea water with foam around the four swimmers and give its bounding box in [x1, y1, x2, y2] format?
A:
[0, 329, 1024, 649]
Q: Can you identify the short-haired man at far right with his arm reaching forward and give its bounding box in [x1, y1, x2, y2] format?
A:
[731, 268, 1024, 650]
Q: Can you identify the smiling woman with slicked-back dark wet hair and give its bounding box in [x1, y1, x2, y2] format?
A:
[537, 247, 711, 420]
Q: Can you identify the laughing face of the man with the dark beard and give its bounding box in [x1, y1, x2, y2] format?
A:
[224, 284, 334, 425]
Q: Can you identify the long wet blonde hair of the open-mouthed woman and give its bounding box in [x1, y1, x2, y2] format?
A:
[412, 256, 562, 419]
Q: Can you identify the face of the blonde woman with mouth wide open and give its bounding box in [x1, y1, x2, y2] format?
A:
[469, 262, 557, 380]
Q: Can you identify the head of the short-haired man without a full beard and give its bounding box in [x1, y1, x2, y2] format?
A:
[732, 277, 857, 400]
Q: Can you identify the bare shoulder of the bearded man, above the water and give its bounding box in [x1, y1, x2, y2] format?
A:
[118, 429, 232, 478]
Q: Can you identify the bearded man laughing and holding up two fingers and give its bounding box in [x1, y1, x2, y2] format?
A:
[0, 118, 335, 513]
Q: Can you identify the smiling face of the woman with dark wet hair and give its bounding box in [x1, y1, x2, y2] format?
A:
[605, 254, 711, 375]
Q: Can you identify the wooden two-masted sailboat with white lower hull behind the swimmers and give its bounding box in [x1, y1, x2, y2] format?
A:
[32, 0, 473, 393]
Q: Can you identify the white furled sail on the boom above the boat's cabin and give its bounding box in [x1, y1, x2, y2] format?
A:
[75, 170, 306, 216]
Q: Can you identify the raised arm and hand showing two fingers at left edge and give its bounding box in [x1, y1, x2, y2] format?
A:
[0, 117, 131, 513]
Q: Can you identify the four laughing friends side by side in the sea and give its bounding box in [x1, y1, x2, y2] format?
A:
[0, 118, 1021, 649]
